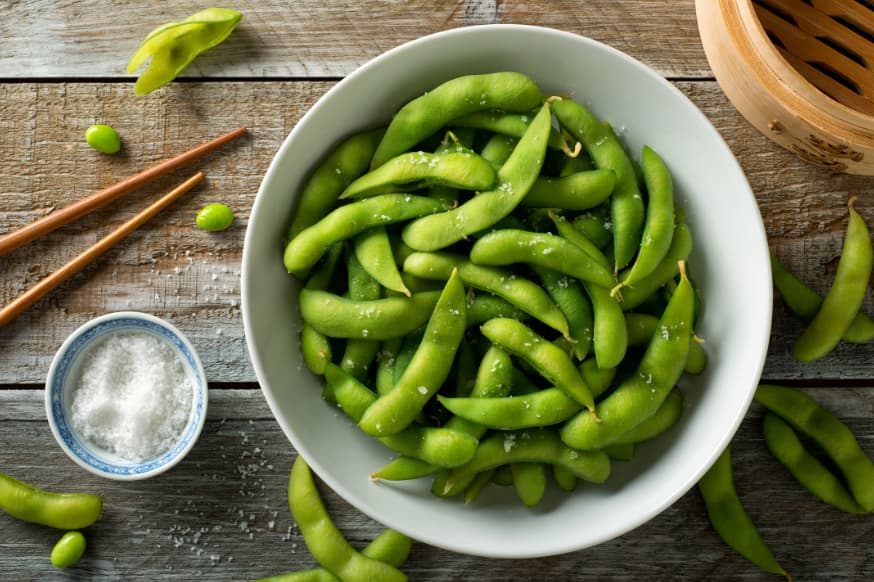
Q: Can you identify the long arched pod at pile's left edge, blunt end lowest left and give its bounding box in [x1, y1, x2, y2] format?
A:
[283, 194, 444, 275]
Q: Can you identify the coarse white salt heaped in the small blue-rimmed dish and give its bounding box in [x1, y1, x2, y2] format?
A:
[70, 331, 194, 463]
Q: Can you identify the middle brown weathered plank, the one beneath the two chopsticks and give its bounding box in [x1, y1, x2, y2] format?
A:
[0, 82, 874, 384]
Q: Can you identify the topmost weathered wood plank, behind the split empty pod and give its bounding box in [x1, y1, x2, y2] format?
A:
[0, 0, 711, 79]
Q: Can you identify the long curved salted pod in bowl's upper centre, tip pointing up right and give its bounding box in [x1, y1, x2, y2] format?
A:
[401, 104, 551, 251]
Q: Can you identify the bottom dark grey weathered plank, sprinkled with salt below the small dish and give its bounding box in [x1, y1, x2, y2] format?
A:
[0, 387, 874, 581]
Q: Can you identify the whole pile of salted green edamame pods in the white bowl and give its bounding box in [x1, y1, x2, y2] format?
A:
[284, 72, 706, 506]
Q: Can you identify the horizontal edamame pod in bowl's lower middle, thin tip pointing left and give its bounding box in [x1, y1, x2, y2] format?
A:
[437, 388, 582, 430]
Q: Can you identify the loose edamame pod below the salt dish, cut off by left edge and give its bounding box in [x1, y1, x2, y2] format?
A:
[0, 473, 103, 530]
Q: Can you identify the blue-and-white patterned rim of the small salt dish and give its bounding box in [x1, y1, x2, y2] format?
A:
[45, 311, 209, 481]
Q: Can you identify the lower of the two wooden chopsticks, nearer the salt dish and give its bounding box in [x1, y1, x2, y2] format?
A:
[0, 172, 203, 326]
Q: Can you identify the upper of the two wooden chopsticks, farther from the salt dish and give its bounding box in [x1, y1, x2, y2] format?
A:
[0, 127, 246, 256]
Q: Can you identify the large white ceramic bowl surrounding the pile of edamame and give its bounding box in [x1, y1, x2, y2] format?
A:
[242, 25, 771, 558]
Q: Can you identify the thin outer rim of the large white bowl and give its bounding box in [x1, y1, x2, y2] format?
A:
[241, 24, 773, 558]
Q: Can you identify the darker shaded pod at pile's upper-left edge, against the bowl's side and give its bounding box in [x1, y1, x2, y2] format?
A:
[286, 129, 385, 240]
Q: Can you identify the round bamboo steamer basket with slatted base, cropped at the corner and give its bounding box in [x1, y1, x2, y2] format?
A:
[695, 0, 874, 176]
